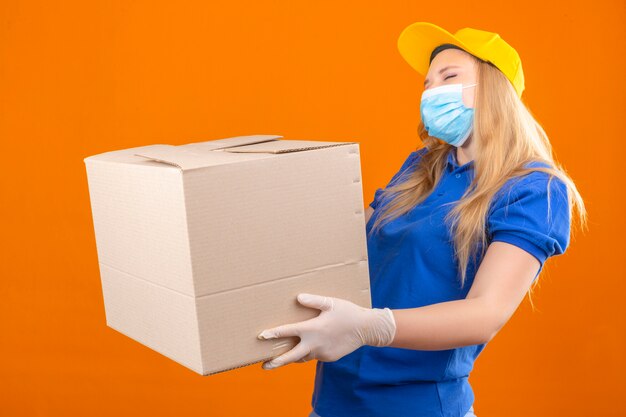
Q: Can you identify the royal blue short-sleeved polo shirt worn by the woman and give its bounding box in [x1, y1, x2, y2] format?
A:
[311, 147, 570, 417]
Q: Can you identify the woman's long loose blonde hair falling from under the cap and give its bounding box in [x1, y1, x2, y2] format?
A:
[370, 54, 587, 292]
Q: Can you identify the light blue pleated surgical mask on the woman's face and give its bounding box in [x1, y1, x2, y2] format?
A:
[420, 83, 478, 147]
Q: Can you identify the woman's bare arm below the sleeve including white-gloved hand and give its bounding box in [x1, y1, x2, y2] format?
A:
[258, 237, 539, 369]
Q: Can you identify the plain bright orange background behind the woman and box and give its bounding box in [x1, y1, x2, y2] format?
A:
[0, 0, 626, 417]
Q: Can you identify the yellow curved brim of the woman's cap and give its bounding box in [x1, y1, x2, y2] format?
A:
[398, 22, 468, 76]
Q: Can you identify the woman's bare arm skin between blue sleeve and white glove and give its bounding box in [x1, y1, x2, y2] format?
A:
[390, 242, 539, 350]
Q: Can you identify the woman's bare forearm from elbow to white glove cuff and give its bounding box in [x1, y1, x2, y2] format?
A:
[389, 298, 497, 350]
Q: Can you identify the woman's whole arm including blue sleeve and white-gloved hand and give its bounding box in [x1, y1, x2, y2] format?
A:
[259, 172, 570, 369]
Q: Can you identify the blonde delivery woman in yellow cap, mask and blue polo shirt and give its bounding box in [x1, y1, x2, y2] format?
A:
[259, 22, 586, 417]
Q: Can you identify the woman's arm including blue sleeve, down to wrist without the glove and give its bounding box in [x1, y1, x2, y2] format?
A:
[391, 174, 571, 350]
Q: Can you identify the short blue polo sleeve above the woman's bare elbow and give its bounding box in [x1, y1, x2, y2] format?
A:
[487, 175, 570, 279]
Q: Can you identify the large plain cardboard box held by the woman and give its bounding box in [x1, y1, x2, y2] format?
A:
[84, 135, 371, 375]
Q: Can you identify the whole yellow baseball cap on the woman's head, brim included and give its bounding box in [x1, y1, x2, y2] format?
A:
[398, 22, 524, 97]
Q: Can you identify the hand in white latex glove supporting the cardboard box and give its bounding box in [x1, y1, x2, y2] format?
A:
[258, 293, 396, 369]
